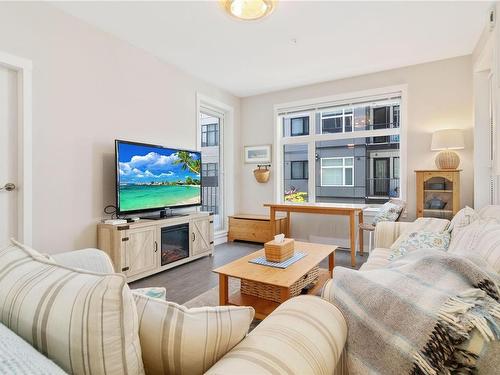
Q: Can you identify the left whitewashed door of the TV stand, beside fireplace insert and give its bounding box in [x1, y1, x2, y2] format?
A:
[124, 227, 158, 277]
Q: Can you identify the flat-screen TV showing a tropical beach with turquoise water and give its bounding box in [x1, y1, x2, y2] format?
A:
[115, 140, 201, 214]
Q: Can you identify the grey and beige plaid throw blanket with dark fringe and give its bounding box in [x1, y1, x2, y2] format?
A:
[323, 250, 500, 374]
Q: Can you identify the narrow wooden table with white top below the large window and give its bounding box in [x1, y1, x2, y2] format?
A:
[264, 203, 368, 267]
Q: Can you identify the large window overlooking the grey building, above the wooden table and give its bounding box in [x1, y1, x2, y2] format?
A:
[275, 88, 405, 203]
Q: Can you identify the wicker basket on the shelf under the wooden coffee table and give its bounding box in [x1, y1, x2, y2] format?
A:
[241, 266, 319, 303]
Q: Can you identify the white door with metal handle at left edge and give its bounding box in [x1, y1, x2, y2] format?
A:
[0, 66, 18, 248]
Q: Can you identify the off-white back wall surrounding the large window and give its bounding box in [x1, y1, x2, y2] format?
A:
[237, 56, 473, 242]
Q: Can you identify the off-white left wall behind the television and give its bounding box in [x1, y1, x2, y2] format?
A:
[0, 2, 239, 253]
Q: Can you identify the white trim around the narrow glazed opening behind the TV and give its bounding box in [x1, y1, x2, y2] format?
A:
[196, 92, 234, 231]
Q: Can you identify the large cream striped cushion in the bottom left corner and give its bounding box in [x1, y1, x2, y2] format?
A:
[0, 243, 144, 374]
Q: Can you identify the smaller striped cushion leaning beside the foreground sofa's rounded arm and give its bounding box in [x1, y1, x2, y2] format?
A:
[132, 293, 255, 375]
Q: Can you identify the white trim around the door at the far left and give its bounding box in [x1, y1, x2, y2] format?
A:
[0, 51, 33, 245]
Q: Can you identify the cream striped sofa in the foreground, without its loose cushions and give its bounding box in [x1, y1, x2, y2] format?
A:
[0, 249, 347, 375]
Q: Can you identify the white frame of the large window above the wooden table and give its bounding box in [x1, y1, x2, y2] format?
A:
[273, 84, 408, 203]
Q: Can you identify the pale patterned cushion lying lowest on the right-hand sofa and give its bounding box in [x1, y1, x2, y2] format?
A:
[389, 230, 450, 260]
